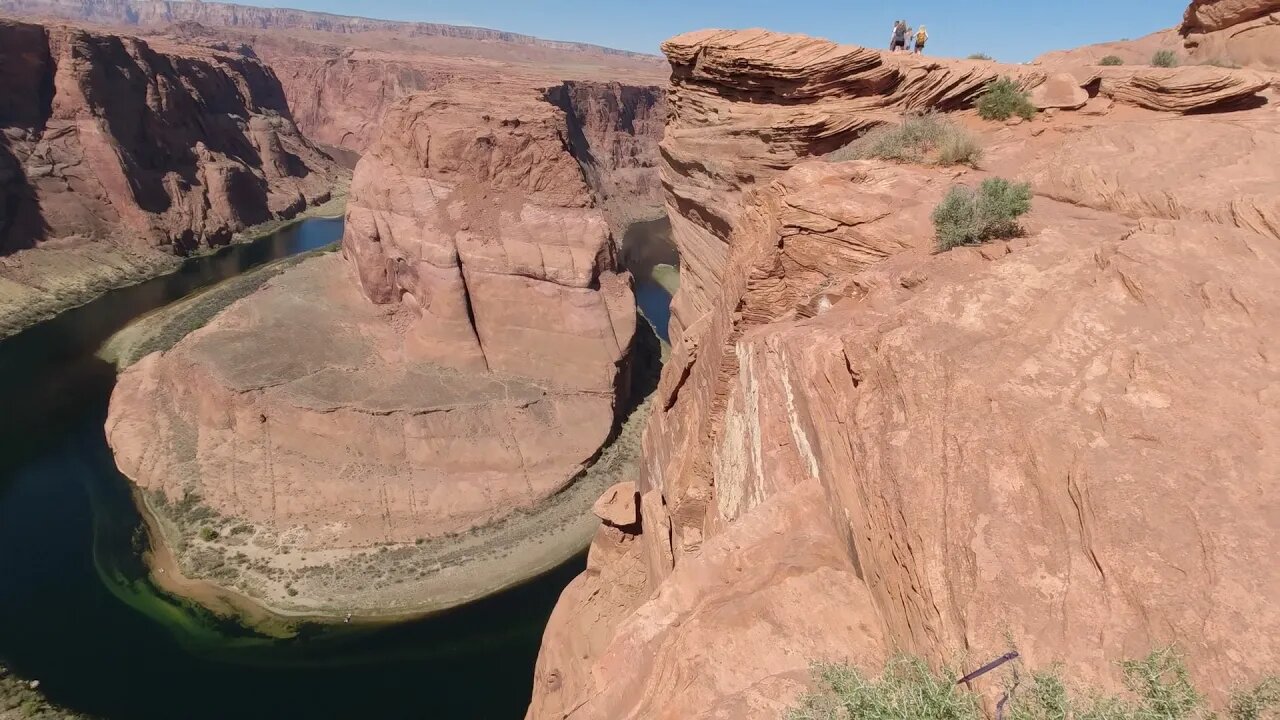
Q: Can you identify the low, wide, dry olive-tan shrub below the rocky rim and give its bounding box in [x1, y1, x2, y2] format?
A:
[827, 113, 982, 167]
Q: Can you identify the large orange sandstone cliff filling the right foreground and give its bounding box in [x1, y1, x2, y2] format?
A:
[529, 31, 1280, 720]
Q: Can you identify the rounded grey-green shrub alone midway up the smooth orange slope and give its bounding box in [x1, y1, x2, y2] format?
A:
[933, 178, 1032, 252]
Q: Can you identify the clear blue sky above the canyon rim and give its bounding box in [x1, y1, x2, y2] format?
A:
[247, 0, 1188, 63]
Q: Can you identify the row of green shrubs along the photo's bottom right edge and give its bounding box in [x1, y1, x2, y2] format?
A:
[786, 648, 1280, 720]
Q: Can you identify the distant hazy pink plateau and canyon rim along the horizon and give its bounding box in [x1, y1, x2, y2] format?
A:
[0, 0, 666, 157]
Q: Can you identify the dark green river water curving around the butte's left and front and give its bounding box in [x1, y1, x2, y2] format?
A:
[0, 220, 584, 720]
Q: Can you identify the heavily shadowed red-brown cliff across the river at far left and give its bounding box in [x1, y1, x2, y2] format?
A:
[0, 20, 342, 254]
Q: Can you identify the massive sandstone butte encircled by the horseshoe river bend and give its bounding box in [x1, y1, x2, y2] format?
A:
[108, 86, 650, 612]
